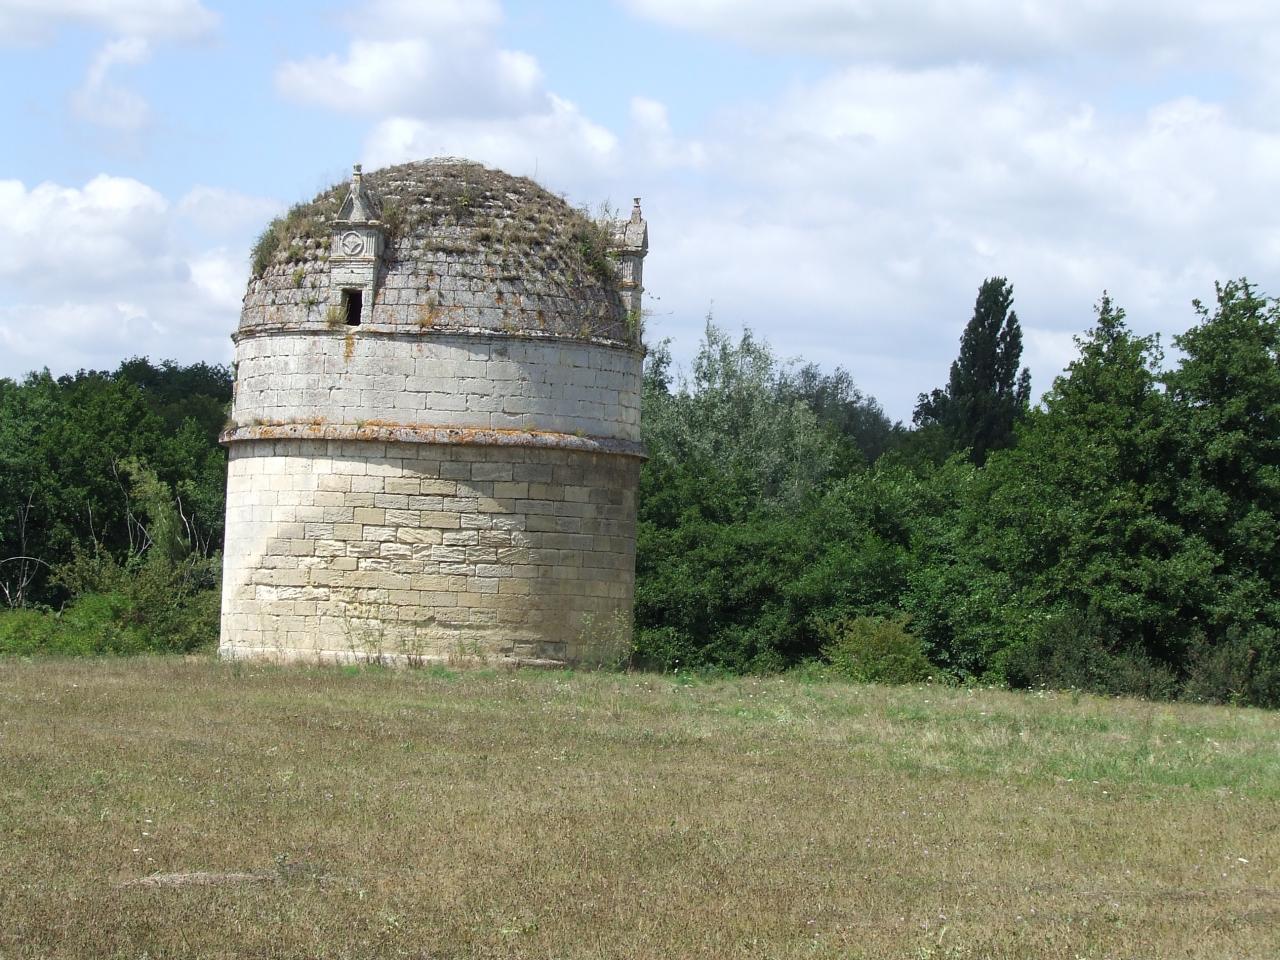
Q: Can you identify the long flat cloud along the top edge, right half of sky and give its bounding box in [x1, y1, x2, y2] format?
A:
[623, 0, 1280, 65]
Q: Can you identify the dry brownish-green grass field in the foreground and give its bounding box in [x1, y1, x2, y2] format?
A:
[0, 658, 1280, 960]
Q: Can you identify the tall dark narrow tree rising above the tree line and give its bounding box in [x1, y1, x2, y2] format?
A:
[913, 276, 1032, 465]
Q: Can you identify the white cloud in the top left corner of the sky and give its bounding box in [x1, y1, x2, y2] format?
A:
[0, 0, 219, 45]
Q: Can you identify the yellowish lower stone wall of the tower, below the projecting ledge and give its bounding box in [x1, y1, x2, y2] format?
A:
[220, 440, 640, 663]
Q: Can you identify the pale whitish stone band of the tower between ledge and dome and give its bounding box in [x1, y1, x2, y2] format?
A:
[232, 328, 641, 443]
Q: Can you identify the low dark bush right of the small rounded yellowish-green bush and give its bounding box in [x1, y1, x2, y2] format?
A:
[997, 611, 1178, 700]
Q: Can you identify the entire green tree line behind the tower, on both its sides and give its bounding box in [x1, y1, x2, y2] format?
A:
[0, 278, 1280, 707]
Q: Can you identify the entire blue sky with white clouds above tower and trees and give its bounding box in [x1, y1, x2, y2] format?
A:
[0, 0, 1280, 421]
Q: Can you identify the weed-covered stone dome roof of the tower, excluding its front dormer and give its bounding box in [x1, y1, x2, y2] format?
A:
[239, 157, 643, 346]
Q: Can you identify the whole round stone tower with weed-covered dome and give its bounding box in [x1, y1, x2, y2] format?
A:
[220, 159, 648, 663]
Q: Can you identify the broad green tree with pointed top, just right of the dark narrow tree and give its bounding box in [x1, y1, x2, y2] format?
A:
[906, 297, 1212, 692]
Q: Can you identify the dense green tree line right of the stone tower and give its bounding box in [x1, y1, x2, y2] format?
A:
[636, 278, 1280, 707]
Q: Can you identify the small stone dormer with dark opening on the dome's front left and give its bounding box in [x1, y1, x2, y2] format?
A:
[329, 164, 387, 326]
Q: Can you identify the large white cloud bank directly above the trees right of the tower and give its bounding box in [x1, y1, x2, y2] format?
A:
[645, 67, 1280, 417]
